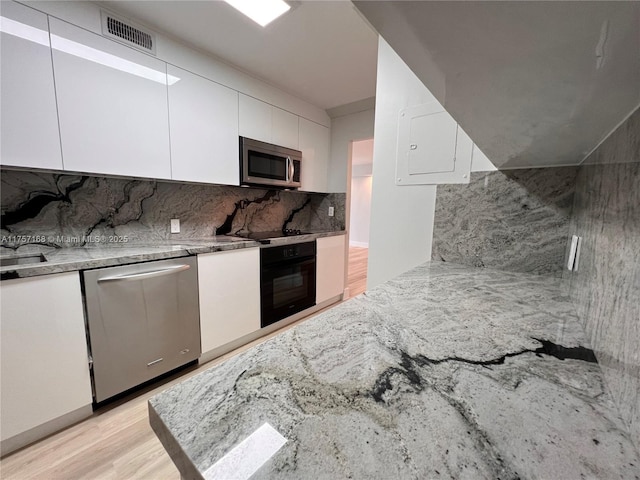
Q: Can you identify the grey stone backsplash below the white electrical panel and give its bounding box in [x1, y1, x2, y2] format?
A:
[431, 167, 578, 276]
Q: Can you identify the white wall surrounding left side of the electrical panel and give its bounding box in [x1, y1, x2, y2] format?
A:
[367, 37, 436, 288]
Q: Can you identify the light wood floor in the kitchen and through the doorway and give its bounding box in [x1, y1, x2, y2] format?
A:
[0, 247, 368, 480]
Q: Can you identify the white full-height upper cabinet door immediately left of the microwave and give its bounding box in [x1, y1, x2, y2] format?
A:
[167, 65, 240, 185]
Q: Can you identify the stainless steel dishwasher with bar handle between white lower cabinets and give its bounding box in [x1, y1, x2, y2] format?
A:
[83, 257, 200, 402]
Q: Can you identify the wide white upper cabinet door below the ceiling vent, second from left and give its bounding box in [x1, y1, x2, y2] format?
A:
[50, 18, 171, 178]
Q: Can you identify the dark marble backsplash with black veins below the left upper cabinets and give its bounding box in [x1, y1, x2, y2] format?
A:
[0, 170, 345, 249]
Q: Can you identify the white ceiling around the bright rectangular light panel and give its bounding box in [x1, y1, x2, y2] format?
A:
[99, 0, 378, 109]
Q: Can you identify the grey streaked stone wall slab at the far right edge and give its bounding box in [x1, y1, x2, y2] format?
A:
[563, 110, 640, 450]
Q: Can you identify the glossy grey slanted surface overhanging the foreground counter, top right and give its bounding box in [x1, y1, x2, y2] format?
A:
[354, 1, 640, 168]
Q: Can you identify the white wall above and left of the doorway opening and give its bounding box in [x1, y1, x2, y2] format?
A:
[329, 109, 375, 193]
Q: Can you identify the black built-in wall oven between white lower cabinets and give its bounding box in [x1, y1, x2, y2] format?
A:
[260, 242, 316, 327]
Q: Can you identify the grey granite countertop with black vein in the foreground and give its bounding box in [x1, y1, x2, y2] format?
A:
[149, 262, 640, 479]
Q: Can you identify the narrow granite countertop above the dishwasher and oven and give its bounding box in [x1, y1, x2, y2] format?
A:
[0, 231, 345, 280]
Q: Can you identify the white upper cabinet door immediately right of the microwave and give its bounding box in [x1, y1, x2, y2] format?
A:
[299, 117, 329, 192]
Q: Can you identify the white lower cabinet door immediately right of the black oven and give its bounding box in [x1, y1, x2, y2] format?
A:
[316, 235, 346, 303]
